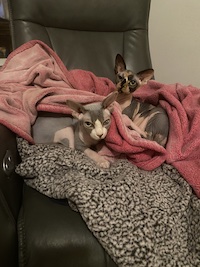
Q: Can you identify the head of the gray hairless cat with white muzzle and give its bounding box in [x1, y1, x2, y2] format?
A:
[67, 92, 118, 141]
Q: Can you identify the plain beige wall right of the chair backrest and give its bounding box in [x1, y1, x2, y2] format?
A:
[149, 0, 200, 88]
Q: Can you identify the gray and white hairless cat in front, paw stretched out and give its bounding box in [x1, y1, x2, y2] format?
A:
[32, 92, 118, 168]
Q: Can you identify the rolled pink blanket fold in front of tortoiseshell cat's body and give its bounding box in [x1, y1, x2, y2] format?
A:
[106, 108, 166, 170]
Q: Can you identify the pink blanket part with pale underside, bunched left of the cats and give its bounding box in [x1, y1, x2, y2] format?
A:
[0, 40, 115, 142]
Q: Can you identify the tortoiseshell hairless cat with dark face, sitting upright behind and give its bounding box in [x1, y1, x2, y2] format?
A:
[115, 54, 169, 146]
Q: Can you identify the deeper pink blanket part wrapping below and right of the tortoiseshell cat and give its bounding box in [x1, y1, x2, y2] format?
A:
[106, 81, 200, 197]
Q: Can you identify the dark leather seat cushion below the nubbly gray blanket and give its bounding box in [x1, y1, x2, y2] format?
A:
[18, 185, 116, 267]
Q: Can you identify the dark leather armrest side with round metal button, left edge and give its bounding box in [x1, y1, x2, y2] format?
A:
[0, 125, 23, 267]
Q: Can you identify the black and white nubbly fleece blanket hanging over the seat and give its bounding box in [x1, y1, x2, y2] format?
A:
[16, 138, 200, 267]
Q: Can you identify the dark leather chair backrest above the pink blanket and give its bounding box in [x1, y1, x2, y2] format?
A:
[8, 0, 151, 80]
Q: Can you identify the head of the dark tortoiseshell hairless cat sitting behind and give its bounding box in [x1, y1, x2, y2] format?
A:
[114, 54, 154, 94]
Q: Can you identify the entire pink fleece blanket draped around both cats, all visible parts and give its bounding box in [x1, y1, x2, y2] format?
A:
[0, 40, 200, 197]
